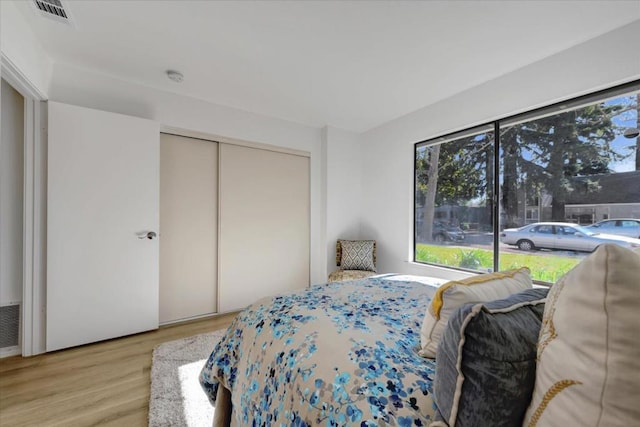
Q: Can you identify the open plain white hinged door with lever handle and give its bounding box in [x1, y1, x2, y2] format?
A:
[46, 102, 160, 351]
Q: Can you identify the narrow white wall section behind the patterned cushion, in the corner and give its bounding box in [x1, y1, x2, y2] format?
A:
[323, 127, 368, 275]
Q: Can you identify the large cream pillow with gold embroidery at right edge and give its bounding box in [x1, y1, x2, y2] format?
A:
[523, 245, 640, 427]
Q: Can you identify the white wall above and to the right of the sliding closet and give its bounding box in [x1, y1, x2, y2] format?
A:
[49, 63, 327, 283]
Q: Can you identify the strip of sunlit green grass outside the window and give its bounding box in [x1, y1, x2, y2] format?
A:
[416, 244, 582, 283]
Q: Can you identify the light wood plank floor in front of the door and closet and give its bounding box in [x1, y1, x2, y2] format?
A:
[0, 313, 236, 427]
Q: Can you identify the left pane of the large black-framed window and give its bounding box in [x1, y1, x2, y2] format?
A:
[415, 127, 495, 269]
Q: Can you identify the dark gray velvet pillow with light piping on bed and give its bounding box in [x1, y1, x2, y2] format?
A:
[434, 288, 549, 427]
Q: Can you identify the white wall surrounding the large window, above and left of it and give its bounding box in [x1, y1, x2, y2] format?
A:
[360, 21, 640, 277]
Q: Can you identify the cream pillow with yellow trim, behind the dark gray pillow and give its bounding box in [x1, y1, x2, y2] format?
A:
[418, 267, 533, 358]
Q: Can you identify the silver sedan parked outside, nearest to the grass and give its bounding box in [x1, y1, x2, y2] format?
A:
[500, 222, 640, 252]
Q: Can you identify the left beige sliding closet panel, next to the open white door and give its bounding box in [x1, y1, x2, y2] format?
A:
[160, 134, 218, 323]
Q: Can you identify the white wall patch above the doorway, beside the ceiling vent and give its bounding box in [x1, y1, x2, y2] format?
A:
[0, 1, 53, 99]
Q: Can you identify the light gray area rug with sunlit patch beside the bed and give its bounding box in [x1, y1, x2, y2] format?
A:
[149, 330, 225, 427]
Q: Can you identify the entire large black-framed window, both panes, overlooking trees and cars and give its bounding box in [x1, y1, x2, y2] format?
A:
[414, 83, 640, 282]
